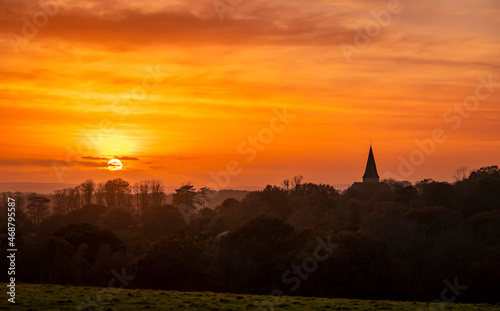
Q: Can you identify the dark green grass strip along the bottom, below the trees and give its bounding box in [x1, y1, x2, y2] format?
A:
[0, 283, 500, 311]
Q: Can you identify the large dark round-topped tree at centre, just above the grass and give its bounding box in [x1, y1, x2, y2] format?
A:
[218, 216, 300, 294]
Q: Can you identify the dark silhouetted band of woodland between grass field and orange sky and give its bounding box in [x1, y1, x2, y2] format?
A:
[0, 166, 500, 302]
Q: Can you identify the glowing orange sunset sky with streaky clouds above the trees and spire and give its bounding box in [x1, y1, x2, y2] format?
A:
[0, 0, 500, 188]
